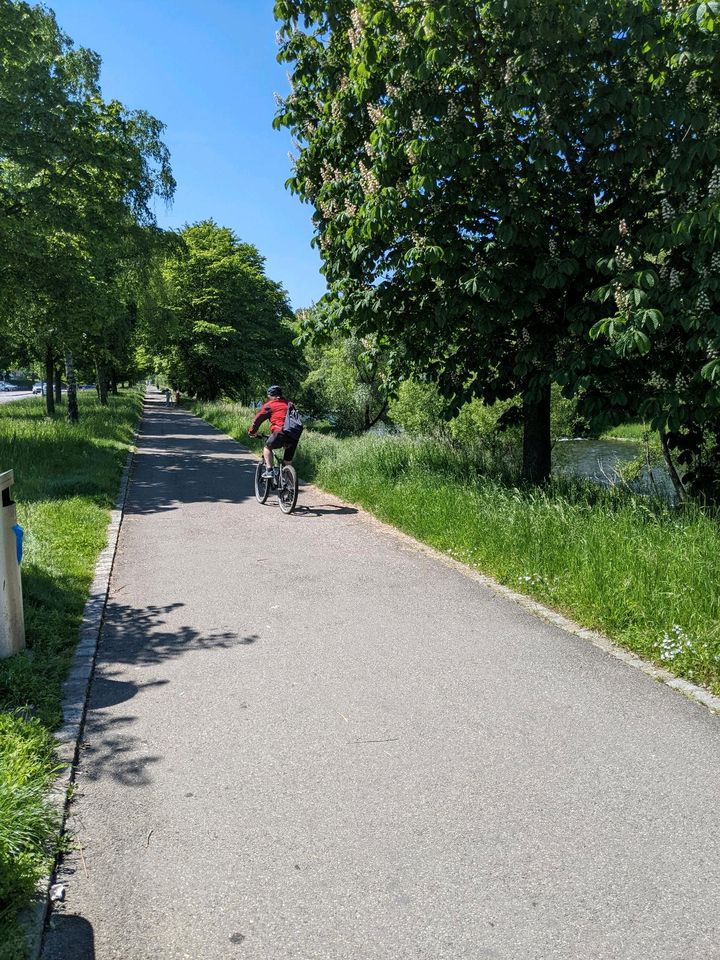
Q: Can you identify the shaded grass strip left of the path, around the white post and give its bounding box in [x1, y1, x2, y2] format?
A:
[0, 391, 141, 960]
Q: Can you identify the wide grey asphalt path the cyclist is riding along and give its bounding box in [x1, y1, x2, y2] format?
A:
[44, 392, 720, 960]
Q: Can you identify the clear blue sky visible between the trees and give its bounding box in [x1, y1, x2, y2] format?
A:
[48, 0, 325, 308]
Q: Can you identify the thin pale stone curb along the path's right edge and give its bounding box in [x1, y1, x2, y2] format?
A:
[193, 410, 720, 716]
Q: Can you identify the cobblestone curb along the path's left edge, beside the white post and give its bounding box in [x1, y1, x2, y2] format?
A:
[20, 434, 139, 960]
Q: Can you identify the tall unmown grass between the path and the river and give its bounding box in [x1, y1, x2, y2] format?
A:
[195, 404, 720, 694]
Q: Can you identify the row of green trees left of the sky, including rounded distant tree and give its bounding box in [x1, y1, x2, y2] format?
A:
[0, 0, 290, 421]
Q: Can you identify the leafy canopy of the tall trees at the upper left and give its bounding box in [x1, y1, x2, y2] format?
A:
[0, 0, 175, 418]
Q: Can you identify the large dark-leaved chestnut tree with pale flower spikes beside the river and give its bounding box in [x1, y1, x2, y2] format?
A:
[275, 0, 720, 496]
